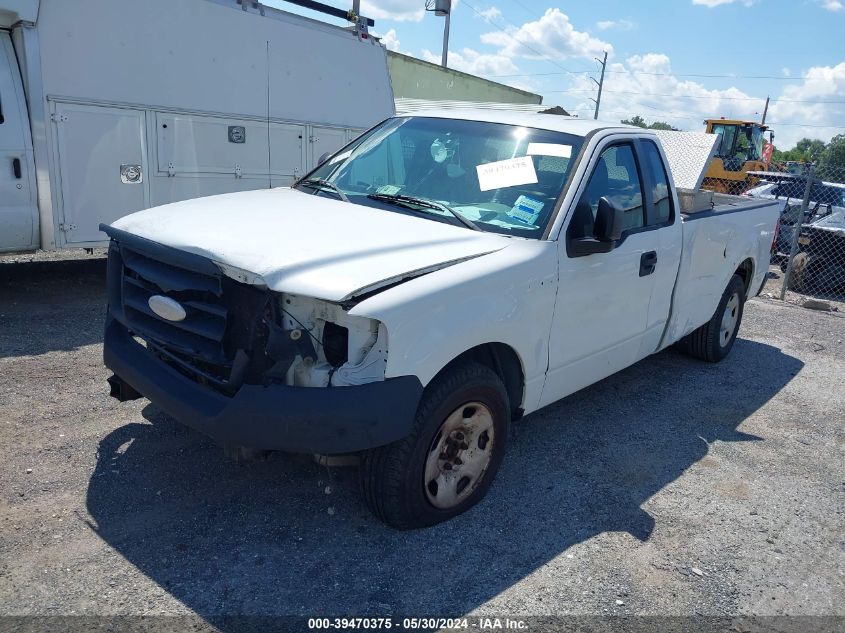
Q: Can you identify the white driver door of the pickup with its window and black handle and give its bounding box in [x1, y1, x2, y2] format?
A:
[541, 140, 659, 406]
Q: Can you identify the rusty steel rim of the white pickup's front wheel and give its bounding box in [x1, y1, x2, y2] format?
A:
[423, 402, 495, 510]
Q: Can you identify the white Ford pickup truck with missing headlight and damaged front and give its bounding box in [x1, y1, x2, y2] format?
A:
[102, 111, 783, 528]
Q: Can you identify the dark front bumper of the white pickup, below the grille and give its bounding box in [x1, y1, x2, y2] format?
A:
[103, 318, 423, 455]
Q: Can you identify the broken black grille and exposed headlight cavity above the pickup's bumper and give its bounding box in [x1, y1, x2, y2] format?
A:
[103, 227, 387, 395]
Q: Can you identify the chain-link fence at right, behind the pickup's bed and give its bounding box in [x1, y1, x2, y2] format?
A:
[704, 160, 845, 309]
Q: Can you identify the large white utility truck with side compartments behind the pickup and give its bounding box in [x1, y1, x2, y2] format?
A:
[0, 0, 394, 252]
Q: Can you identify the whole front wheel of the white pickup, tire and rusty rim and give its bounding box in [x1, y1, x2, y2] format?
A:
[361, 362, 510, 529]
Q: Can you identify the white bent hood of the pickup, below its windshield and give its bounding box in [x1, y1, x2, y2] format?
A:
[112, 188, 510, 301]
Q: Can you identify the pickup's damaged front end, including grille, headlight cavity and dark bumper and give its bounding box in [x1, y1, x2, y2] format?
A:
[103, 228, 423, 455]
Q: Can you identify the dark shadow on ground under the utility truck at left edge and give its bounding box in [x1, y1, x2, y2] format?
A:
[0, 257, 106, 358]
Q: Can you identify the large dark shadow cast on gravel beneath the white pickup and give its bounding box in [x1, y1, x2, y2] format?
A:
[87, 339, 802, 621]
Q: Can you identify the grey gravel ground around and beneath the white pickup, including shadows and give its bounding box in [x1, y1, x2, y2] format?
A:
[0, 253, 845, 619]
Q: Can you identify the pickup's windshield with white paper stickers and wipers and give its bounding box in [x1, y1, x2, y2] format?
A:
[295, 117, 583, 238]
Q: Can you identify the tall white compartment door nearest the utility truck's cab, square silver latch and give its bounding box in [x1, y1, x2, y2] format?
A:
[53, 103, 149, 245]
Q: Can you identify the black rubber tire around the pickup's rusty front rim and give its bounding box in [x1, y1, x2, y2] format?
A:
[361, 362, 510, 530]
